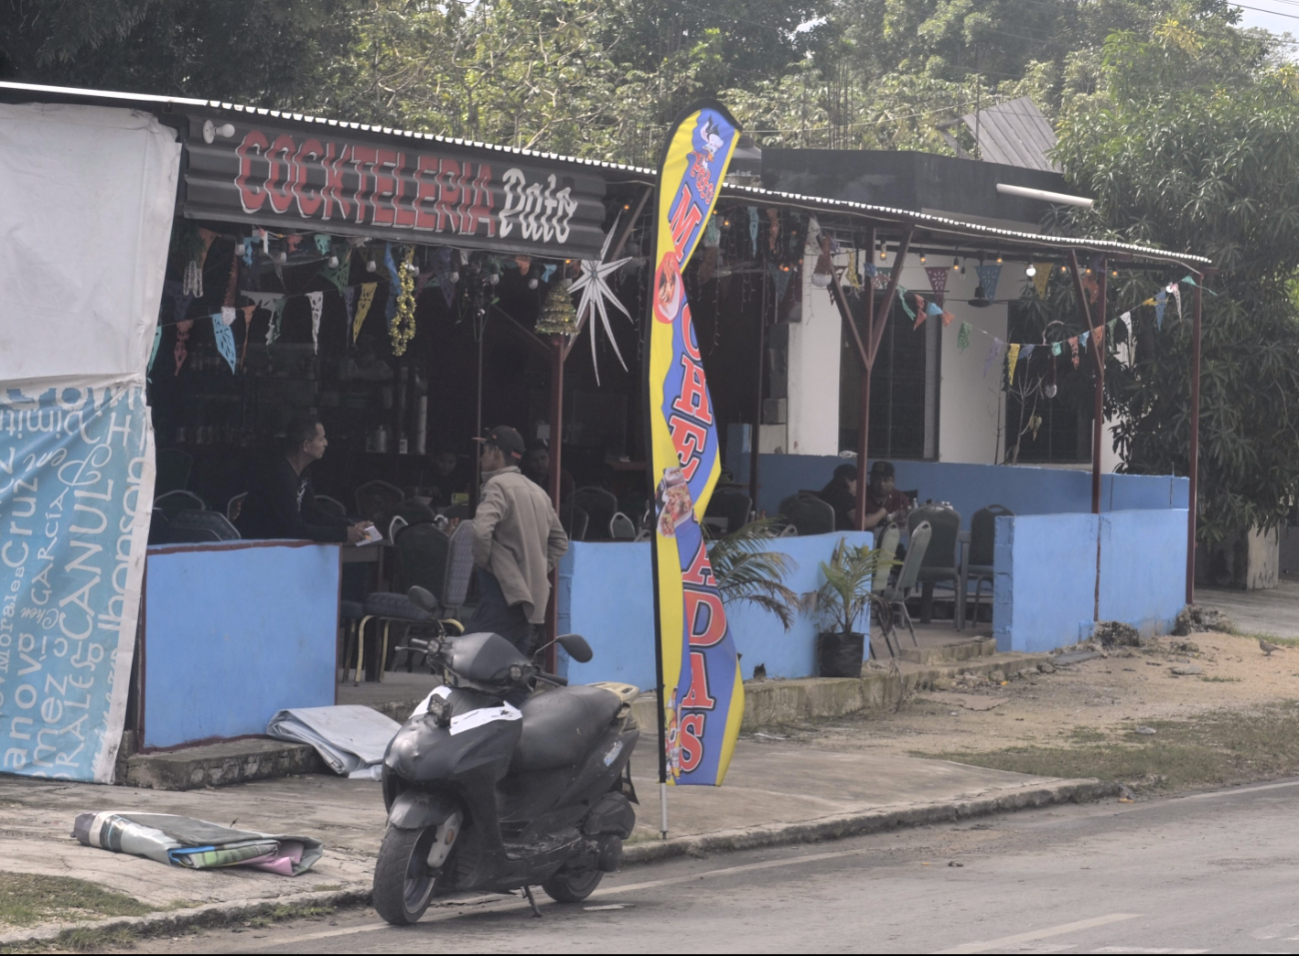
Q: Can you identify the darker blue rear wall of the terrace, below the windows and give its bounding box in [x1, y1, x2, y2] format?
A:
[727, 455, 1189, 527]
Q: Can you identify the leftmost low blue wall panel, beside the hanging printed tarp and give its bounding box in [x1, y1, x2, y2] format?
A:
[143, 542, 339, 747]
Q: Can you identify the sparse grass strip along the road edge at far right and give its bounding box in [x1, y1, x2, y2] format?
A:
[922, 701, 1299, 790]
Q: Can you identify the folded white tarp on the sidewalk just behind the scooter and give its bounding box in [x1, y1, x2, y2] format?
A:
[266, 704, 401, 778]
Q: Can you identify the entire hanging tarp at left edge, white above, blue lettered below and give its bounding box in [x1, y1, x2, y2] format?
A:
[0, 104, 181, 783]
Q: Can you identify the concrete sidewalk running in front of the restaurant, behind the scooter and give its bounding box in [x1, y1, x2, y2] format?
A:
[0, 738, 1104, 947]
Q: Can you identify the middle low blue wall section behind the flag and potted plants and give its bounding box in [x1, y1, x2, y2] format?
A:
[559, 531, 872, 688]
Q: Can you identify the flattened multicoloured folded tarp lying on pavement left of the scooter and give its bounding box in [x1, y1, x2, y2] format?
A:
[73, 811, 325, 877]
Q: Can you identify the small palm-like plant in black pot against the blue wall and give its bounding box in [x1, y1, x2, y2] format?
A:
[816, 538, 896, 677]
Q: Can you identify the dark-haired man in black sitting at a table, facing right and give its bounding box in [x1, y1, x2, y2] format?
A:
[238, 417, 373, 544]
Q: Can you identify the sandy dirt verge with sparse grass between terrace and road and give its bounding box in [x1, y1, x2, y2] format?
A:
[759, 634, 1299, 792]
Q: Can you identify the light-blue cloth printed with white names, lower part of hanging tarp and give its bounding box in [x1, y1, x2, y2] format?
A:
[0, 384, 153, 783]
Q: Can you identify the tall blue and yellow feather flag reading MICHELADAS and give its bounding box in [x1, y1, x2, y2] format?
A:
[644, 103, 744, 786]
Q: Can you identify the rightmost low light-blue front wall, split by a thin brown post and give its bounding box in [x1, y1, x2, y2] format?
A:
[992, 508, 1186, 652]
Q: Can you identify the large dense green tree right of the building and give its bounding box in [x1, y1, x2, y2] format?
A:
[1057, 12, 1299, 544]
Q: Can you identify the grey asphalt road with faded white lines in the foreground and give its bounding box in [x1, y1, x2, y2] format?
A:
[136, 781, 1299, 953]
